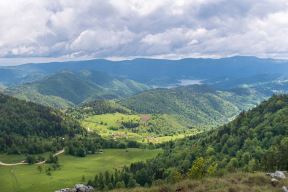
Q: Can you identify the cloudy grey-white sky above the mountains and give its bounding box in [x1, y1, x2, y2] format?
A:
[0, 0, 288, 63]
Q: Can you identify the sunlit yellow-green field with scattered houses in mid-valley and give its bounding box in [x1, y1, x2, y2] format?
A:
[81, 113, 199, 143]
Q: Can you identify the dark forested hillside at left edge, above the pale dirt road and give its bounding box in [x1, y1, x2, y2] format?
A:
[0, 94, 83, 153]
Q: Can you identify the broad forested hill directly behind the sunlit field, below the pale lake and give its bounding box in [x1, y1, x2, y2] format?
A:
[120, 85, 263, 127]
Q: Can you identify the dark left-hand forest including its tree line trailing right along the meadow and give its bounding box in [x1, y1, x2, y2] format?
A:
[0, 94, 139, 157]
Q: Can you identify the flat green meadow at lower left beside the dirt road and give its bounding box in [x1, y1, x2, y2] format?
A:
[0, 149, 161, 192]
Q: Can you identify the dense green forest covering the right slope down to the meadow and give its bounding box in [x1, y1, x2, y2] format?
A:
[89, 95, 288, 190]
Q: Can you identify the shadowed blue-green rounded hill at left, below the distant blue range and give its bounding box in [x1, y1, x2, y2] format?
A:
[5, 70, 148, 108]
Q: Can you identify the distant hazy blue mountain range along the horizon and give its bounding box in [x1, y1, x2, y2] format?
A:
[0, 56, 288, 87]
